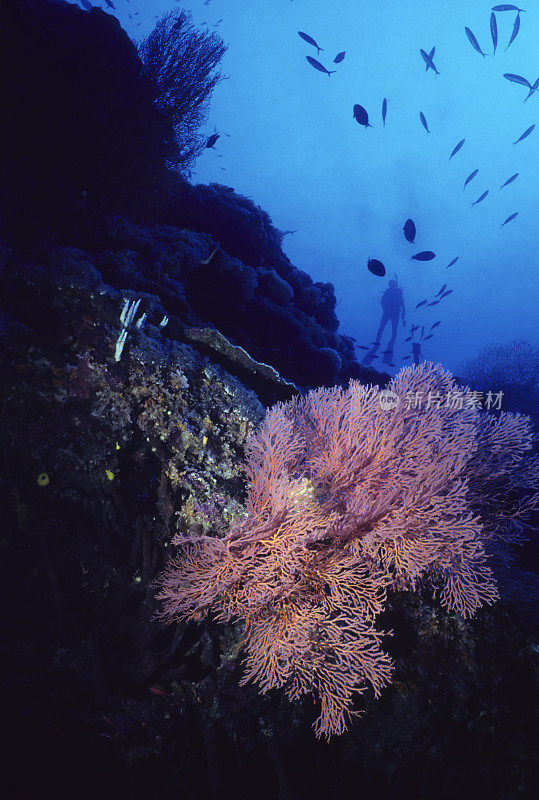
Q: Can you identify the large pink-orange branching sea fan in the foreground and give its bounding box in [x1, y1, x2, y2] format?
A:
[154, 363, 539, 738]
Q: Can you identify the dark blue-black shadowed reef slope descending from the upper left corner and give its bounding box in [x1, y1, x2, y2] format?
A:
[2, 0, 388, 394]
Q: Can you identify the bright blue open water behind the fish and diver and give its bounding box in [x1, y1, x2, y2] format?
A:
[139, 0, 539, 373]
